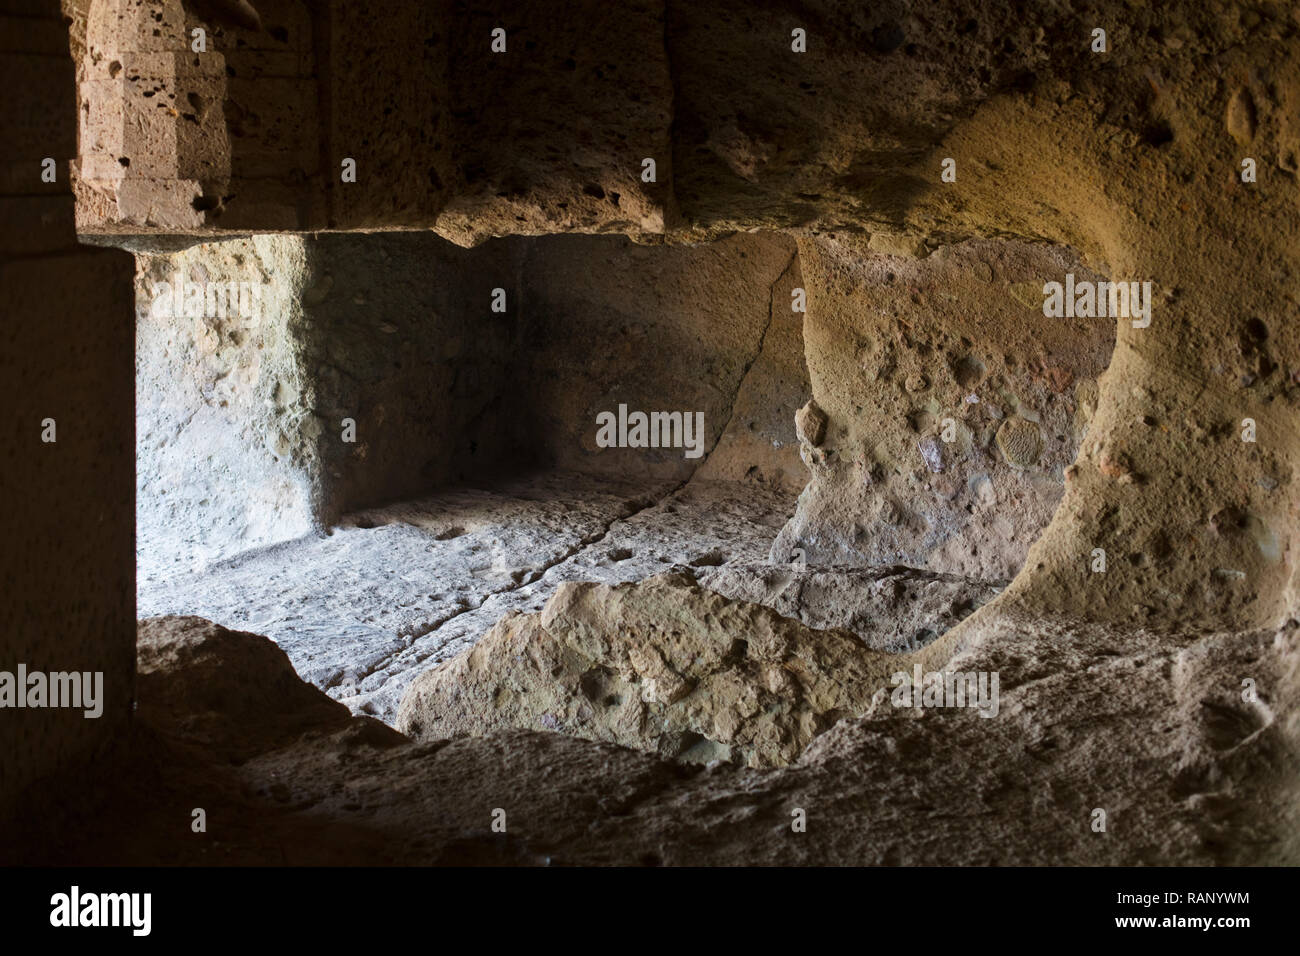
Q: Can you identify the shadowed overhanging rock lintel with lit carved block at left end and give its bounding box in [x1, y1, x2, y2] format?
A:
[65, 0, 1086, 243]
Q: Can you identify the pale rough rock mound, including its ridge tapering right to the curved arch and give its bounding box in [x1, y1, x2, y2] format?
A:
[398, 562, 998, 766]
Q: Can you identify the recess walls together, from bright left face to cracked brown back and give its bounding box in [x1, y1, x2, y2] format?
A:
[137, 233, 809, 578]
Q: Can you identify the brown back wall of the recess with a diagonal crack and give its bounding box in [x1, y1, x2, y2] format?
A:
[512, 234, 807, 484]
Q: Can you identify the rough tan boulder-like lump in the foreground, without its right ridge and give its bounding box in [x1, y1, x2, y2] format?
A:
[398, 575, 888, 767]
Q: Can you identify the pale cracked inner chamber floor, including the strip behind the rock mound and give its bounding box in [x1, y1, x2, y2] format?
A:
[138, 473, 1000, 723]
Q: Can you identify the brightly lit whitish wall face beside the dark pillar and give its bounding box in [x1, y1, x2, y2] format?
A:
[135, 235, 322, 580]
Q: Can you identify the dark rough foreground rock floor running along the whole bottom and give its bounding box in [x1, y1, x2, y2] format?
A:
[15, 607, 1300, 866]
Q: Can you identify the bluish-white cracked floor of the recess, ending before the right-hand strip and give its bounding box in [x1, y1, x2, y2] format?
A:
[139, 473, 792, 721]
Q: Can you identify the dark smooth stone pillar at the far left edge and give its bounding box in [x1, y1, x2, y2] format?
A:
[0, 0, 135, 819]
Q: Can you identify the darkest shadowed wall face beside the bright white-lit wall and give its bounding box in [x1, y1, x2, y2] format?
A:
[296, 233, 519, 523]
